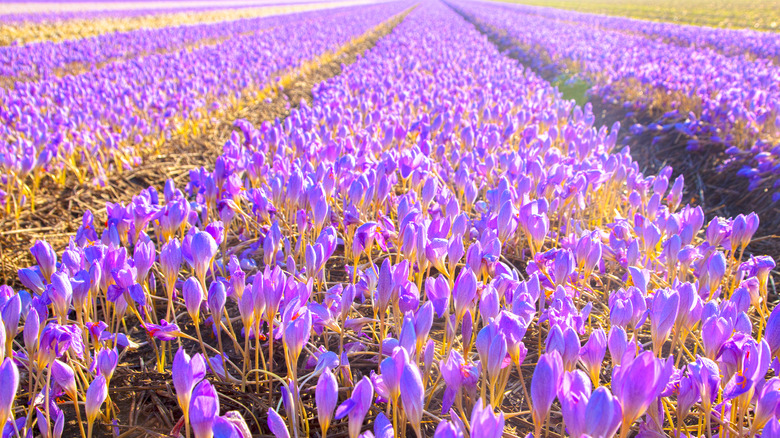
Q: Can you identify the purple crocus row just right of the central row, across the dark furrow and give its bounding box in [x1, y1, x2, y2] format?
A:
[458, 3, 780, 204]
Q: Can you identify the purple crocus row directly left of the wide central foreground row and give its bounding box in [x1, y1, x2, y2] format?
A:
[0, 3, 412, 216]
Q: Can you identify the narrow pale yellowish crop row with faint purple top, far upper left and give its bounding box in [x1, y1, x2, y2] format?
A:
[0, 1, 368, 46]
